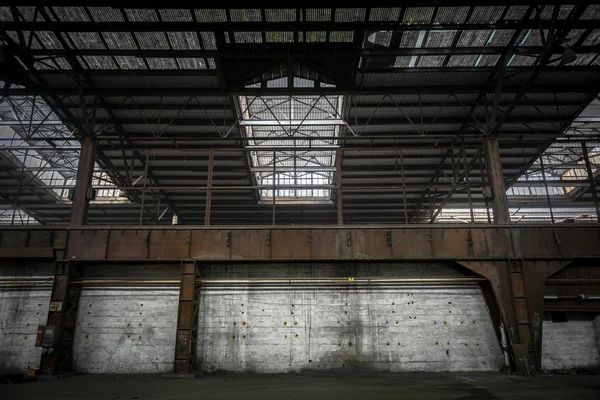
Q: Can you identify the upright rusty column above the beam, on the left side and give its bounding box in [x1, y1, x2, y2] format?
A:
[69, 136, 96, 225]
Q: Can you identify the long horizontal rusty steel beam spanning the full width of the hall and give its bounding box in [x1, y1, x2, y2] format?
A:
[0, 224, 600, 262]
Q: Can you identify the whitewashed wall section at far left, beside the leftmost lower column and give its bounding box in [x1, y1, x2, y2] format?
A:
[0, 263, 52, 374]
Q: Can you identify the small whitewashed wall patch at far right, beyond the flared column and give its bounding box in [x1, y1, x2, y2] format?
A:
[542, 313, 600, 370]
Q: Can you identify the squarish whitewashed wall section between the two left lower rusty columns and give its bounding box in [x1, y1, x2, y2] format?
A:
[73, 286, 179, 373]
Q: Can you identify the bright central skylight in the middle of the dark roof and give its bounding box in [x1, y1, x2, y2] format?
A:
[239, 77, 344, 204]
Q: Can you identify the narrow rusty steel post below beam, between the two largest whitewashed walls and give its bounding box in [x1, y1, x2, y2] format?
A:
[173, 261, 198, 373]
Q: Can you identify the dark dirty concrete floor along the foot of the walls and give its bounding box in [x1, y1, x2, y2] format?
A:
[0, 373, 600, 400]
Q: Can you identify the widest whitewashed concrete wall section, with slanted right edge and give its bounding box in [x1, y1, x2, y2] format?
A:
[198, 284, 503, 372]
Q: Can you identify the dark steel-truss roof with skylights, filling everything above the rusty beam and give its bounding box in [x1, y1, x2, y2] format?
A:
[0, 1, 600, 224]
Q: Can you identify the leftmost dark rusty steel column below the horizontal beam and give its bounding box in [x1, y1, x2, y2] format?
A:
[40, 261, 81, 375]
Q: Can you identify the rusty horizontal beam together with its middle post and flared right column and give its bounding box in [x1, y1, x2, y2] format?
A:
[0, 224, 600, 375]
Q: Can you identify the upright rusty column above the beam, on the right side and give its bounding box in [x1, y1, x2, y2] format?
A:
[483, 137, 510, 224]
